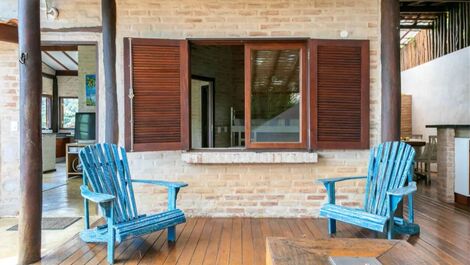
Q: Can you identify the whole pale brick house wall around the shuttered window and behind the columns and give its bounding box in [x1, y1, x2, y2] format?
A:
[0, 0, 380, 216]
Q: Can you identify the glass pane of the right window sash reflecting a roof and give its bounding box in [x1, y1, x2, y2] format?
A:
[250, 49, 300, 143]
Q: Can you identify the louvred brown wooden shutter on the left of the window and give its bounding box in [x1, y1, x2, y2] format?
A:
[124, 39, 189, 151]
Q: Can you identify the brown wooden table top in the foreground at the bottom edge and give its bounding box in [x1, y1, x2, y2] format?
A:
[266, 237, 439, 265]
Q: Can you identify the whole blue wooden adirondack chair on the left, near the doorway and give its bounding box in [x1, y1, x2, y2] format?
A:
[79, 144, 187, 264]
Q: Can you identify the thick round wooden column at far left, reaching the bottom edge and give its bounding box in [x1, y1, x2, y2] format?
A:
[18, 0, 42, 264]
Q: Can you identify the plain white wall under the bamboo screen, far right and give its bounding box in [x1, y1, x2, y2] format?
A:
[401, 47, 470, 139]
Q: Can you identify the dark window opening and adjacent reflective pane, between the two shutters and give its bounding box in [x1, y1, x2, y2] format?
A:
[191, 45, 300, 149]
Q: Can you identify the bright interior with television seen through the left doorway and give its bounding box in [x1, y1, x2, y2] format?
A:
[41, 44, 97, 216]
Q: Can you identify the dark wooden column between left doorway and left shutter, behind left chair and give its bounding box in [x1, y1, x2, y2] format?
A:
[101, 0, 119, 143]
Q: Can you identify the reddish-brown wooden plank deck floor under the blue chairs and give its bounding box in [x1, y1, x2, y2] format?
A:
[38, 190, 470, 265]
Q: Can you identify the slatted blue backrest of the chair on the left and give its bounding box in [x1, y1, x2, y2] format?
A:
[79, 143, 138, 223]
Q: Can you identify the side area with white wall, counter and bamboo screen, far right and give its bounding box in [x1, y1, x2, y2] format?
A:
[400, 2, 470, 205]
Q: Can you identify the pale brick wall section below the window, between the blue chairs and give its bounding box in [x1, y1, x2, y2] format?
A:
[129, 151, 368, 216]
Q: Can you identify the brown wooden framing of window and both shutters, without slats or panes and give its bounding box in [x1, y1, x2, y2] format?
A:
[124, 38, 371, 152]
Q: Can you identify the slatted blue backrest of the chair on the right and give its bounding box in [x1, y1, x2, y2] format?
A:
[364, 142, 415, 216]
